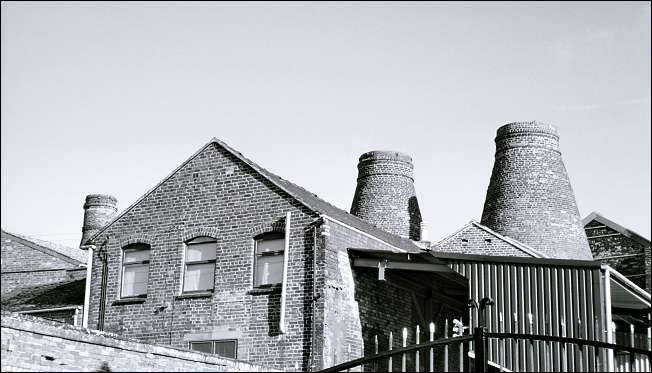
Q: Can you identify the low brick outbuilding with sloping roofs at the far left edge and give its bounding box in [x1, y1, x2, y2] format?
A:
[1, 230, 86, 325]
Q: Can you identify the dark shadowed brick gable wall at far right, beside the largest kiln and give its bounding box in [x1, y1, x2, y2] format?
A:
[585, 220, 651, 292]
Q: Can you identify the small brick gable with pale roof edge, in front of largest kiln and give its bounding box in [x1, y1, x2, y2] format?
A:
[430, 220, 547, 258]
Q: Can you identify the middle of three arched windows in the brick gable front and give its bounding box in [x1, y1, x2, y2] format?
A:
[183, 237, 217, 293]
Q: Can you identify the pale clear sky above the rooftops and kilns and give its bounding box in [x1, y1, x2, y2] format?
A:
[1, 2, 651, 246]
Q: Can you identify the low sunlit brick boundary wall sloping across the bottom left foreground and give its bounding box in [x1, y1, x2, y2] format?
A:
[1, 311, 272, 372]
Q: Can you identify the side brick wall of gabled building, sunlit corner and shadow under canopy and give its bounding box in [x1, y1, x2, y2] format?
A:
[318, 220, 466, 369]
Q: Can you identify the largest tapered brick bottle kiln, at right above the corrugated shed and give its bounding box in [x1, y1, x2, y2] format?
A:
[481, 122, 593, 260]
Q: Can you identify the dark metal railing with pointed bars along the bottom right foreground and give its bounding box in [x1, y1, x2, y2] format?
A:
[321, 298, 652, 372]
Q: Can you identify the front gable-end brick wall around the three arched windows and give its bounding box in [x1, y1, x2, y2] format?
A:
[89, 144, 317, 370]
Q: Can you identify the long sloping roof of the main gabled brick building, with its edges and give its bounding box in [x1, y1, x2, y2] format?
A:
[88, 137, 422, 253]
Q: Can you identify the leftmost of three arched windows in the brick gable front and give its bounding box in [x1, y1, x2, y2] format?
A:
[120, 243, 149, 298]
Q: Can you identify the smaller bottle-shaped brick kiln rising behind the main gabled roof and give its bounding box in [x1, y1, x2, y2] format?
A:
[351, 151, 421, 241]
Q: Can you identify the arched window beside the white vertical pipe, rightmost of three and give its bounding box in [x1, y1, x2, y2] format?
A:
[254, 233, 285, 286]
